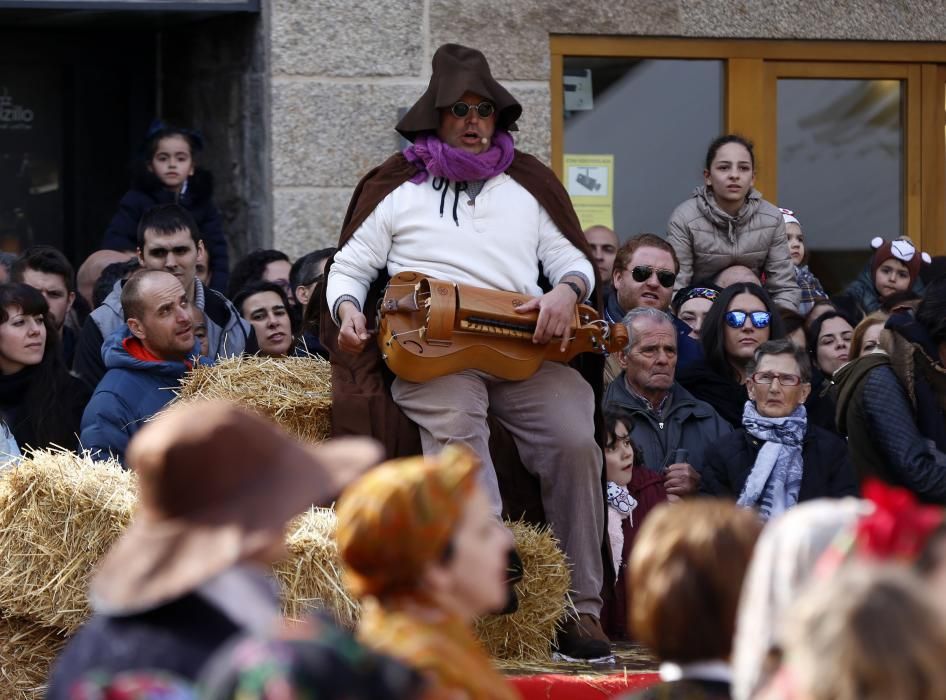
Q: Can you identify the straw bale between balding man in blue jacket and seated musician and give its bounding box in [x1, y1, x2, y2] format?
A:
[178, 356, 332, 443]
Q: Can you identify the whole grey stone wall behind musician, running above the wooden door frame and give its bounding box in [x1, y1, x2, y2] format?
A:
[269, 0, 946, 256]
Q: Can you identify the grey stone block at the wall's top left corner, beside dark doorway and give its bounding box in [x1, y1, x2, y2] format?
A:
[270, 0, 424, 76]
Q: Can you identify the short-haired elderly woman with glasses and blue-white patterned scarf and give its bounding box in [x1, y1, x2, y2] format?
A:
[701, 340, 857, 520]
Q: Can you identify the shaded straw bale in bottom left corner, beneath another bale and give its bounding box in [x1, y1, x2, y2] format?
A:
[0, 617, 66, 700]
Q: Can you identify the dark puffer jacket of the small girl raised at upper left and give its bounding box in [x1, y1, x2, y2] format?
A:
[102, 168, 230, 294]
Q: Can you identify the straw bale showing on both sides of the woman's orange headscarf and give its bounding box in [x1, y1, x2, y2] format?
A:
[276, 508, 571, 662]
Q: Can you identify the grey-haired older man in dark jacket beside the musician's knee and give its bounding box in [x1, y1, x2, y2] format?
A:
[603, 307, 732, 500]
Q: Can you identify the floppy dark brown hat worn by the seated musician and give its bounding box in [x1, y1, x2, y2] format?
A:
[394, 44, 522, 142]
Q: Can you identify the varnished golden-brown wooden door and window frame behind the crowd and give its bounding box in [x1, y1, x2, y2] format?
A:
[549, 35, 946, 255]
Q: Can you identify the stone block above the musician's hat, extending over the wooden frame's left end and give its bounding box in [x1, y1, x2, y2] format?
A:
[430, 0, 681, 80]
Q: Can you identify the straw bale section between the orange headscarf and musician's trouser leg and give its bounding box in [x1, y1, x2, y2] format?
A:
[476, 521, 571, 662]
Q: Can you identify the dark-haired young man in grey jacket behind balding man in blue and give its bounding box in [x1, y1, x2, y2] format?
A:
[73, 204, 256, 388]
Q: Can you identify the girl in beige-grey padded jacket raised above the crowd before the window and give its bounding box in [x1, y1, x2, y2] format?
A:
[667, 134, 801, 309]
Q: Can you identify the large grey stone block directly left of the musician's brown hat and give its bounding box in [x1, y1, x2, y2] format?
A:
[272, 79, 426, 187]
